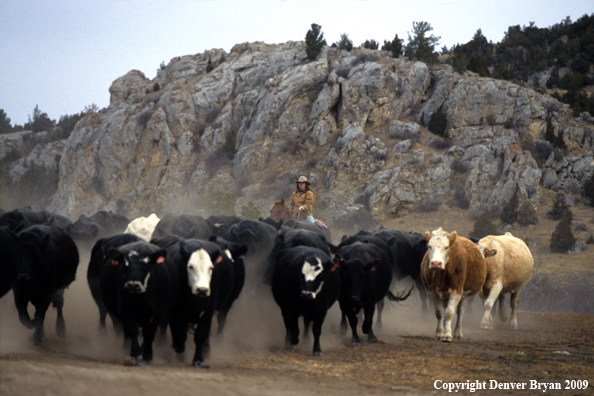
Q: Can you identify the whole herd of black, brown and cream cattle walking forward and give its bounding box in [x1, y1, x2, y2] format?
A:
[0, 208, 533, 366]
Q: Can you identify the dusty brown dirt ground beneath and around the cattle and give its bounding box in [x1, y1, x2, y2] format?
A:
[0, 201, 594, 396]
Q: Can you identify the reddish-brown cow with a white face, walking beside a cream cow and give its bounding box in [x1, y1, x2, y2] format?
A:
[421, 227, 487, 342]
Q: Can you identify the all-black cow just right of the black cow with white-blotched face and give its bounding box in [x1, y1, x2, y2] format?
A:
[335, 241, 392, 346]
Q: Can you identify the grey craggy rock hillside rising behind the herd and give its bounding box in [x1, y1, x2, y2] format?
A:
[0, 42, 594, 226]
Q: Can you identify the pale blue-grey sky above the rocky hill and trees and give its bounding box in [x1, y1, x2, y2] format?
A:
[0, 0, 594, 125]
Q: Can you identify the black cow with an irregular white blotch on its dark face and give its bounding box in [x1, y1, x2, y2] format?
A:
[272, 246, 340, 356]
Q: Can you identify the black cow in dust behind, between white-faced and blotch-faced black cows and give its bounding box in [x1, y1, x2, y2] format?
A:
[223, 220, 277, 285]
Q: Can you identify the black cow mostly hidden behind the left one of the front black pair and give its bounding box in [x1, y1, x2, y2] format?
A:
[87, 234, 142, 332]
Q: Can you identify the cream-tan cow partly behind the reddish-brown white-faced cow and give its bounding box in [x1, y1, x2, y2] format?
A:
[478, 232, 534, 329]
